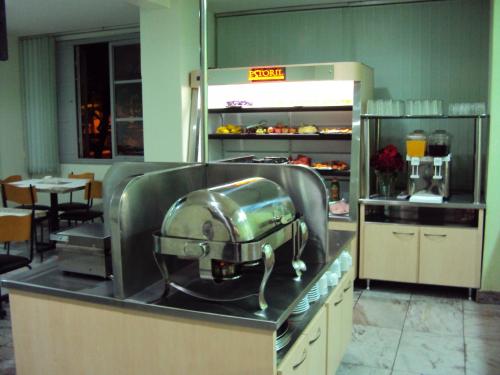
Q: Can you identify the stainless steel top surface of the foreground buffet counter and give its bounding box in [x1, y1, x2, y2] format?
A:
[2, 231, 354, 330]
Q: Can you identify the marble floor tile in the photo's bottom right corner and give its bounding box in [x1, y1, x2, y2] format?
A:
[465, 337, 500, 375]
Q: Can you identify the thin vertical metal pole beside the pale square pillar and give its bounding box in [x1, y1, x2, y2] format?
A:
[197, 0, 208, 162]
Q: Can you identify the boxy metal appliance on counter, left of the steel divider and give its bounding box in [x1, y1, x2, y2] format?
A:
[50, 223, 112, 278]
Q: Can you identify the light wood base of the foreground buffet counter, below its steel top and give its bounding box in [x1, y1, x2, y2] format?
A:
[10, 268, 353, 375]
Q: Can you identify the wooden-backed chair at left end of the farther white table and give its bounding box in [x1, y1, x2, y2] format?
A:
[0, 184, 50, 261]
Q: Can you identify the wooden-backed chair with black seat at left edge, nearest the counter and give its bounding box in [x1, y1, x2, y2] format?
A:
[0, 215, 33, 318]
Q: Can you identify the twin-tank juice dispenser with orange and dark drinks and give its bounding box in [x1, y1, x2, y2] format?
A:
[406, 130, 451, 203]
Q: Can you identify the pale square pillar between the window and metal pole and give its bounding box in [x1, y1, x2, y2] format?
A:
[140, 0, 200, 161]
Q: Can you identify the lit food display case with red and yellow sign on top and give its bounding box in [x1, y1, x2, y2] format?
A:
[191, 62, 373, 220]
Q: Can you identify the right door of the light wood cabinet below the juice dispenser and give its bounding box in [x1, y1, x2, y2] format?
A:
[419, 227, 481, 288]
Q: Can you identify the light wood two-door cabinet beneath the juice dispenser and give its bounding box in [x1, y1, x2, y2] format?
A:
[360, 208, 484, 288]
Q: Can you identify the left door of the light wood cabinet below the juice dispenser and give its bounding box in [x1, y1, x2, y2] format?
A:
[360, 223, 419, 283]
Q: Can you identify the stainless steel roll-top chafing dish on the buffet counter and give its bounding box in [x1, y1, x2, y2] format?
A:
[154, 177, 308, 309]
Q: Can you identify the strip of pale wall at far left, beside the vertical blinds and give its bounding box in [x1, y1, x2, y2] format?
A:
[0, 36, 26, 178]
